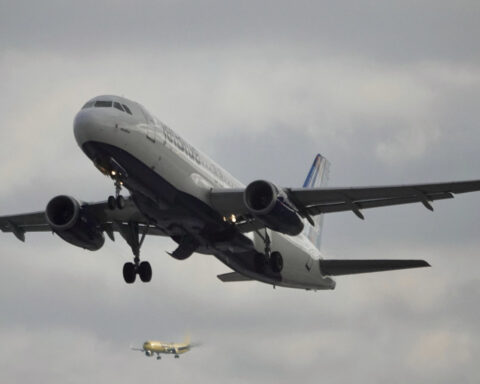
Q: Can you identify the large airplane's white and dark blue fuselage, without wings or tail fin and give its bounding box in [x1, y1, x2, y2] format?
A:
[74, 96, 335, 289]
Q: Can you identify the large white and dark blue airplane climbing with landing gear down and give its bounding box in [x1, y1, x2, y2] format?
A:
[0, 95, 480, 290]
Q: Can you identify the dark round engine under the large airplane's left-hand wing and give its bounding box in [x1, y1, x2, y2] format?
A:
[45, 195, 105, 251]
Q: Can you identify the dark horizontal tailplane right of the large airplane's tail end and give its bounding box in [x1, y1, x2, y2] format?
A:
[320, 260, 430, 276]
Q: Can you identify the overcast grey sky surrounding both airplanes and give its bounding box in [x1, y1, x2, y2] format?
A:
[0, 0, 480, 384]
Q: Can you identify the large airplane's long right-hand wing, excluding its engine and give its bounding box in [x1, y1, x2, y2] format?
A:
[210, 180, 480, 219]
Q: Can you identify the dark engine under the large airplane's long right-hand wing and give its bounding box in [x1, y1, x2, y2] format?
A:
[243, 180, 303, 236]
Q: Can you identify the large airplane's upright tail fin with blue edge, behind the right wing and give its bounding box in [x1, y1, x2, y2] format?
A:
[303, 154, 330, 249]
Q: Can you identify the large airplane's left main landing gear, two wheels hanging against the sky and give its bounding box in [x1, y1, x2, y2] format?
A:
[121, 221, 152, 284]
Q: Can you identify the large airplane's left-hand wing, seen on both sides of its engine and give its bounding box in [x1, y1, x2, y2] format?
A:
[0, 199, 168, 241]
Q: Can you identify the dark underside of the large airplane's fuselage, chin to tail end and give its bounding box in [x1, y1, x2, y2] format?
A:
[83, 142, 331, 289]
